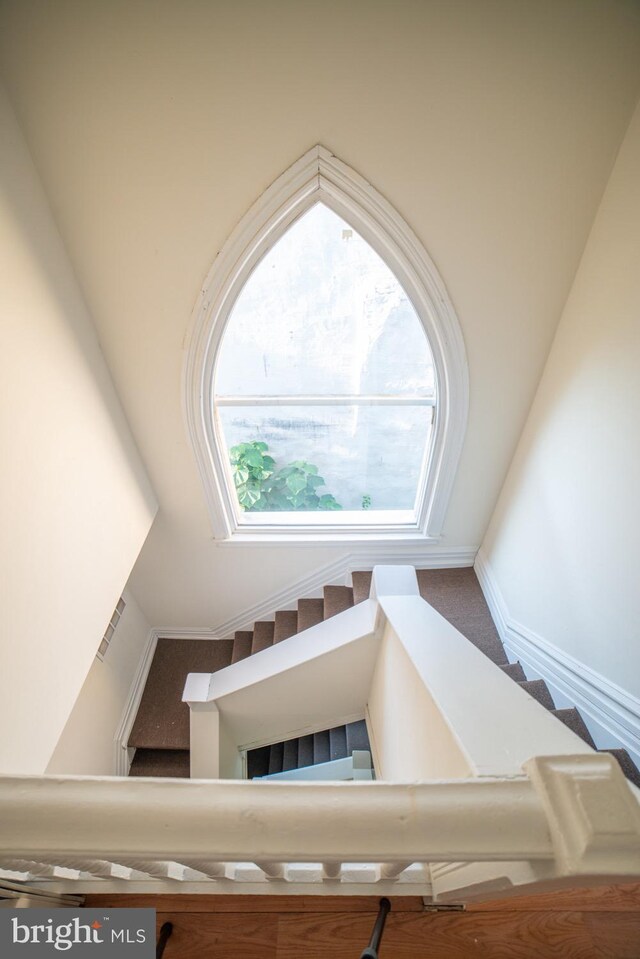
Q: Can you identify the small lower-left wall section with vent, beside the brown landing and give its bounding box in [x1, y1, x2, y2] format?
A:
[46, 590, 150, 776]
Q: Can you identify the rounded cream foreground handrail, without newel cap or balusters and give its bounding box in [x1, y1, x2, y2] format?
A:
[0, 777, 568, 863]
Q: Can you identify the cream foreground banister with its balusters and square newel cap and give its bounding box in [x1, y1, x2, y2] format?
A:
[0, 753, 640, 896]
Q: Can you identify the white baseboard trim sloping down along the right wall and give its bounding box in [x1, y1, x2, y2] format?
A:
[475, 549, 640, 761]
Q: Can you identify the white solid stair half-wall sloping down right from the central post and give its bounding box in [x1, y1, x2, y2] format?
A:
[368, 595, 593, 780]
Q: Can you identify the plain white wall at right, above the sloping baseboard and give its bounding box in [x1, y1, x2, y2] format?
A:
[483, 99, 640, 695]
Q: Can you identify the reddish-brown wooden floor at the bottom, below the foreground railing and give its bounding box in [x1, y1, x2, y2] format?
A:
[86, 884, 640, 959]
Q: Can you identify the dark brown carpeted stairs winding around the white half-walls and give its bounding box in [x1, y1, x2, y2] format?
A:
[128, 568, 640, 786]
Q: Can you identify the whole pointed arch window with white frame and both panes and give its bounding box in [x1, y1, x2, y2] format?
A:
[185, 147, 467, 541]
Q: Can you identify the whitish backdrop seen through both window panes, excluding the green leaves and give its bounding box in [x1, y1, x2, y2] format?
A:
[214, 203, 435, 520]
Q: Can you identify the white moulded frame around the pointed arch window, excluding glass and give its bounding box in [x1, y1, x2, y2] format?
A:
[183, 146, 469, 542]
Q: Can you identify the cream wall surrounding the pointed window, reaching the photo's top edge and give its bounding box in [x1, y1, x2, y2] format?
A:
[0, 0, 640, 626]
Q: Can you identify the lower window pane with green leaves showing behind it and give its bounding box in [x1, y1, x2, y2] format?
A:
[218, 404, 432, 512]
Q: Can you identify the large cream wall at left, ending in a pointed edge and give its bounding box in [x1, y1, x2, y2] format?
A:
[0, 86, 156, 773]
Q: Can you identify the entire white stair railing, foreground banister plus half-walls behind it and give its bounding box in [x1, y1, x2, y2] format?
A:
[0, 567, 640, 902]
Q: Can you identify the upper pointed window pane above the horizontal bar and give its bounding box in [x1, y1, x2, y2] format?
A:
[215, 203, 434, 396]
